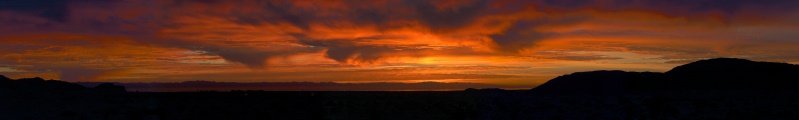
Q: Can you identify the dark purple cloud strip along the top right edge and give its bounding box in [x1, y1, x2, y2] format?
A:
[533, 0, 799, 20]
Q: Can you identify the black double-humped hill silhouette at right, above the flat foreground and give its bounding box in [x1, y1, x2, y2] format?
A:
[532, 58, 799, 96]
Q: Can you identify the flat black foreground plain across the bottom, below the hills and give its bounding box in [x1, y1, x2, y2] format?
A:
[0, 91, 799, 120]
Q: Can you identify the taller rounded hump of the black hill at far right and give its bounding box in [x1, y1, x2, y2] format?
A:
[666, 58, 799, 90]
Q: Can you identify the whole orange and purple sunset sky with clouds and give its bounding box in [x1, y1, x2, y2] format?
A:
[0, 0, 799, 86]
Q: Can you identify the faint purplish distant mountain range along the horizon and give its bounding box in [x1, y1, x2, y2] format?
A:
[77, 81, 526, 92]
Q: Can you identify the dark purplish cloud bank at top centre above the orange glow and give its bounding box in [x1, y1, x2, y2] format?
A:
[212, 0, 494, 32]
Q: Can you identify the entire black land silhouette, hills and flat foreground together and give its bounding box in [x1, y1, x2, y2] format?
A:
[0, 58, 799, 120]
